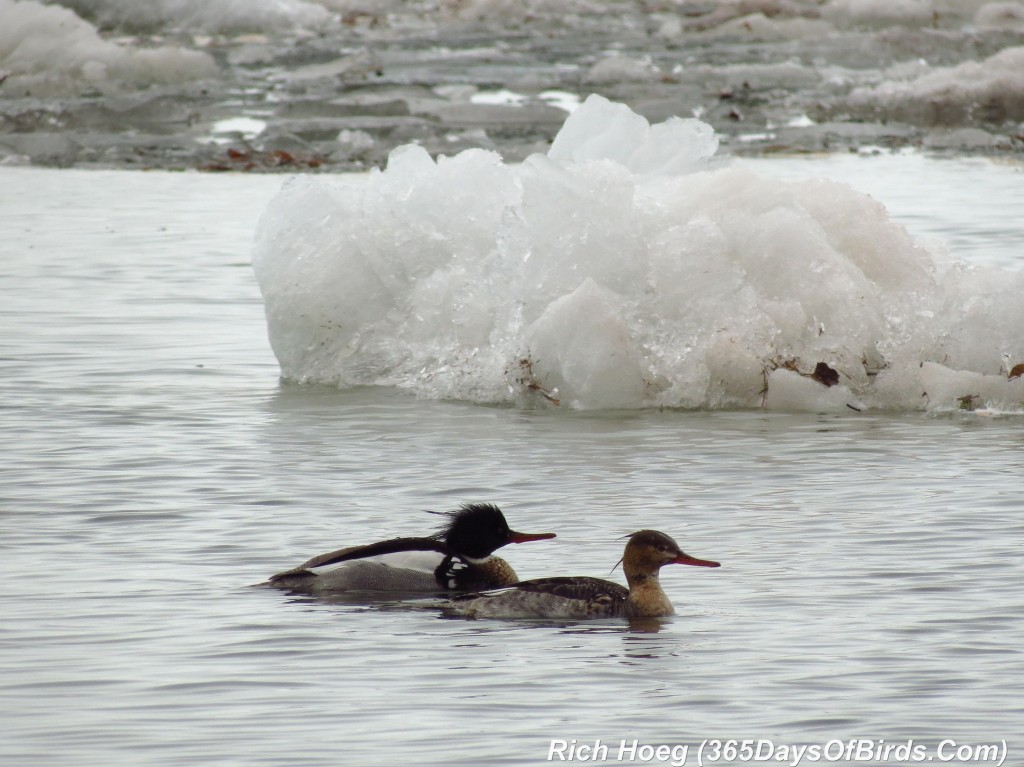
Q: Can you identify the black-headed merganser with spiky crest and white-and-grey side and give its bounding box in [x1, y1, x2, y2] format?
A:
[262, 504, 555, 594]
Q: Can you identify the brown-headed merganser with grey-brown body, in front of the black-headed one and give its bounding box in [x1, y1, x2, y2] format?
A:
[444, 530, 721, 619]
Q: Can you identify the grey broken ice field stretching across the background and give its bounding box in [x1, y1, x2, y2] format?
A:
[0, 0, 1024, 170]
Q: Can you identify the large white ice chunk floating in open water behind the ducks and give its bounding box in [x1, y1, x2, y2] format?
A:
[254, 95, 1024, 410]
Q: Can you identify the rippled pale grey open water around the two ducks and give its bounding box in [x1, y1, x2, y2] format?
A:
[0, 159, 1024, 767]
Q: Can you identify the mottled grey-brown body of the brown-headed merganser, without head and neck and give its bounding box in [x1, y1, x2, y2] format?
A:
[445, 576, 630, 619]
